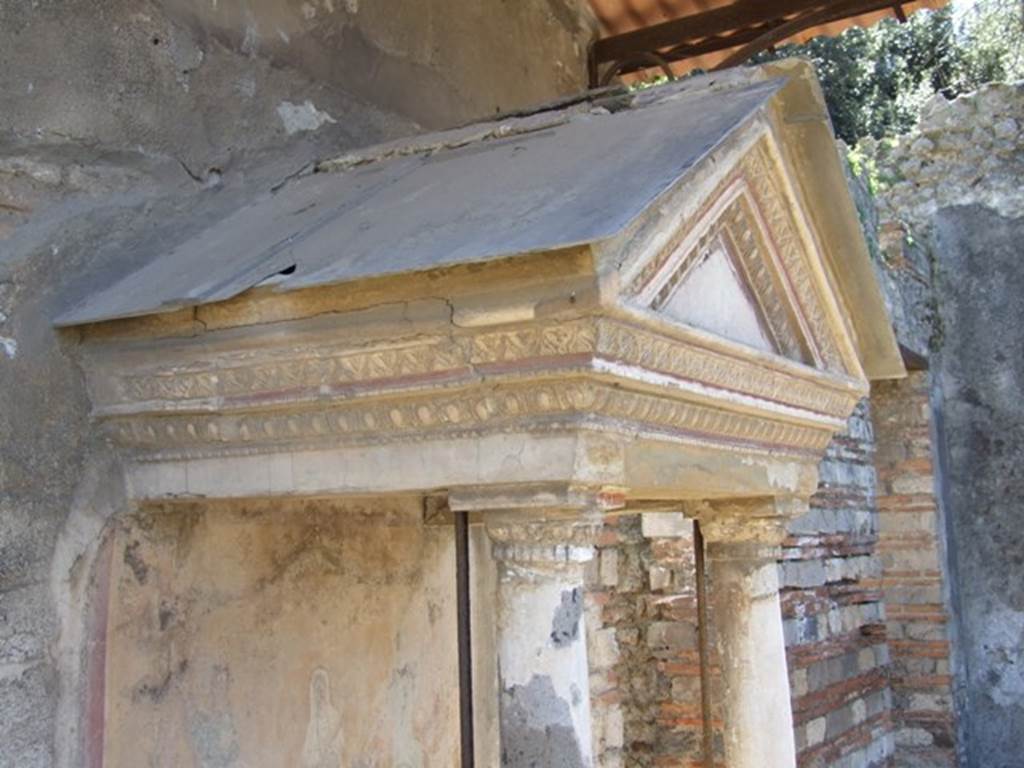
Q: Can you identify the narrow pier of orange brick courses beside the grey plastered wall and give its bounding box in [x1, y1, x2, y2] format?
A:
[871, 371, 956, 768]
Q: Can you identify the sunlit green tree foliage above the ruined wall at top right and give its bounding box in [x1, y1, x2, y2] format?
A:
[755, 0, 1024, 145]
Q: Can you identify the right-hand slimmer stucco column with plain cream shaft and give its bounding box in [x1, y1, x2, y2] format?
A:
[698, 500, 797, 768]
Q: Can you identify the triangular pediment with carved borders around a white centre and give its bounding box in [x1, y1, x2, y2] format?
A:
[627, 138, 858, 382]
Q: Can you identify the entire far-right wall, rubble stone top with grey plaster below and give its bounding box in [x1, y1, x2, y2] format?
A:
[868, 83, 1024, 768]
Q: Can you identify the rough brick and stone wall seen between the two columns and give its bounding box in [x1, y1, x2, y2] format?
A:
[587, 512, 721, 768]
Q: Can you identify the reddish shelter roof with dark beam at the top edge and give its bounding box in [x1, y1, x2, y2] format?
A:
[590, 0, 948, 87]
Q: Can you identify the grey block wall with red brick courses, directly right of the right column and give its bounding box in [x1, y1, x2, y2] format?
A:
[779, 400, 893, 768]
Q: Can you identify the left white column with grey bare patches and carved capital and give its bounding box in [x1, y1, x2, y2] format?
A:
[486, 513, 597, 768]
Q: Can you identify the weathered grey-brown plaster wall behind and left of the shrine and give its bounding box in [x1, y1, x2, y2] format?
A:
[0, 0, 589, 768]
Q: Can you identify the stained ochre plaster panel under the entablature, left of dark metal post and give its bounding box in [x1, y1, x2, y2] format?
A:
[103, 499, 459, 768]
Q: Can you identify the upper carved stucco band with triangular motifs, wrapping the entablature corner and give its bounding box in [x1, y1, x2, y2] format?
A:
[96, 317, 860, 428]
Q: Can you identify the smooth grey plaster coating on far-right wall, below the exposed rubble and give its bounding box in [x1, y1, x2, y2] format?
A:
[935, 208, 1024, 768]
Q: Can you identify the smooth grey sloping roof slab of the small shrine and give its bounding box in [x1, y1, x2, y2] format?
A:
[56, 80, 782, 326]
